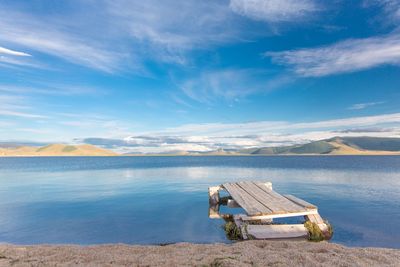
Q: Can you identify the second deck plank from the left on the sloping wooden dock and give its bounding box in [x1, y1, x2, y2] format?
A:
[238, 181, 287, 214]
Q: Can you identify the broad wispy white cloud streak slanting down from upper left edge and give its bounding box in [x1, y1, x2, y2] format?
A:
[0, 8, 131, 72]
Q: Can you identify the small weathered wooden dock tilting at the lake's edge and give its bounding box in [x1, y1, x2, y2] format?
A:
[209, 181, 328, 239]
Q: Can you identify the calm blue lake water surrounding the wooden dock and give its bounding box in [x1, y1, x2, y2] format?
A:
[0, 156, 400, 248]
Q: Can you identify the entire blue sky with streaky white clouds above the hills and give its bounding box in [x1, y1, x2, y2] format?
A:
[0, 0, 400, 153]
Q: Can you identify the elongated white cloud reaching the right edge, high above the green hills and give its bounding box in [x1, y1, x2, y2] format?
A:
[265, 33, 400, 77]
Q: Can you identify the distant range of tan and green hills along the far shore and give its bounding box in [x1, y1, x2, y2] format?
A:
[0, 137, 400, 156]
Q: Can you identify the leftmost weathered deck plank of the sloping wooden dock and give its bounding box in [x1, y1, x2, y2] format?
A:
[223, 183, 272, 216]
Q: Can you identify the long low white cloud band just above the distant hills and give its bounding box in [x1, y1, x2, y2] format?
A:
[82, 113, 400, 153]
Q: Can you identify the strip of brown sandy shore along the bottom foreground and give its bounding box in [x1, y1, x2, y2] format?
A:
[0, 241, 400, 266]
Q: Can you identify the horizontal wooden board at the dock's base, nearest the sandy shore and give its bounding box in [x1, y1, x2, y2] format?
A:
[244, 224, 308, 239]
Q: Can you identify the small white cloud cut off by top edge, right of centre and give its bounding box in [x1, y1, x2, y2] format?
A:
[230, 0, 318, 22]
